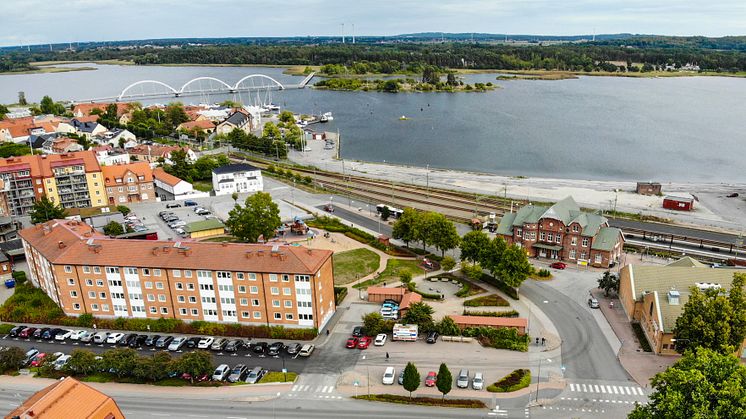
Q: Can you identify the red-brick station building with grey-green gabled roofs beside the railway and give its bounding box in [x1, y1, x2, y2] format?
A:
[497, 197, 624, 268]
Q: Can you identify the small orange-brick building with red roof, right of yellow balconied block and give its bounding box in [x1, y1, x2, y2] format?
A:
[101, 162, 155, 205]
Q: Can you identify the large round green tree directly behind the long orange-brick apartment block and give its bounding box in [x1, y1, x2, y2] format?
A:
[225, 192, 282, 243]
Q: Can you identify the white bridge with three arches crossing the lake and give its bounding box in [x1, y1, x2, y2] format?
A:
[103, 73, 316, 102]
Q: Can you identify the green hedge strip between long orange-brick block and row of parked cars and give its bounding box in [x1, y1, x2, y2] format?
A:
[0, 284, 318, 340]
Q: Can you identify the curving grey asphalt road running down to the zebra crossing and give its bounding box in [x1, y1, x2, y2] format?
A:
[521, 281, 629, 381]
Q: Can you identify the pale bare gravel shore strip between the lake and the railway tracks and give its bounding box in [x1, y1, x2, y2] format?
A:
[288, 140, 746, 234]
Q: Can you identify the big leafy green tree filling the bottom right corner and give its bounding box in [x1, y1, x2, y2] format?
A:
[628, 348, 746, 419]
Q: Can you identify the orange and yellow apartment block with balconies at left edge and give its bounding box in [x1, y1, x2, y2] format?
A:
[0, 151, 106, 216]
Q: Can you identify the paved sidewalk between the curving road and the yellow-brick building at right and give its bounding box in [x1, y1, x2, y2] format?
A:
[591, 289, 679, 388]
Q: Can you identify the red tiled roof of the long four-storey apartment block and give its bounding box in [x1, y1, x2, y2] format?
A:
[19, 220, 333, 275]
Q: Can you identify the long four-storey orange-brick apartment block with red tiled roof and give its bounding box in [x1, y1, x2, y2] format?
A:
[19, 220, 335, 329]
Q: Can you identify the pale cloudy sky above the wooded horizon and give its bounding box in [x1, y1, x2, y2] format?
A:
[0, 0, 746, 46]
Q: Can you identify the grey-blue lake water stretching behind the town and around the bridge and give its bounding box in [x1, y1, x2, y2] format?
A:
[0, 64, 746, 183]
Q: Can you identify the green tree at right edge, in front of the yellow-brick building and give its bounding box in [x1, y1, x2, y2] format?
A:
[673, 274, 746, 354]
